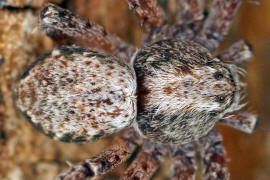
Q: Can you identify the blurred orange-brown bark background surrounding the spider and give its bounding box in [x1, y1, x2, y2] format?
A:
[0, 0, 270, 180]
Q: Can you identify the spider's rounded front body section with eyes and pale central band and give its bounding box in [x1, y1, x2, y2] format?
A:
[134, 39, 235, 144]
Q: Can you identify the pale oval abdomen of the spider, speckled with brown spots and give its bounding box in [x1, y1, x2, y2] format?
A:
[15, 46, 136, 142]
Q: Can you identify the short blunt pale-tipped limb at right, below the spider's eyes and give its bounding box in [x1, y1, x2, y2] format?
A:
[219, 111, 258, 133]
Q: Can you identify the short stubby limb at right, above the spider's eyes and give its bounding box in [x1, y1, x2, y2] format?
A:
[217, 40, 253, 64]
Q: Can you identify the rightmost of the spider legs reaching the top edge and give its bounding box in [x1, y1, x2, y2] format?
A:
[196, 0, 242, 51]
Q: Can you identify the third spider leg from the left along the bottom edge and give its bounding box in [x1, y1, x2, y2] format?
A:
[171, 144, 197, 180]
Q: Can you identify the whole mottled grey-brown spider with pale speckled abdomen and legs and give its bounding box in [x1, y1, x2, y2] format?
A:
[14, 0, 257, 180]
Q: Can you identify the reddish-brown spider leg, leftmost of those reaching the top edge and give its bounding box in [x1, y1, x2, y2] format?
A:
[126, 0, 166, 28]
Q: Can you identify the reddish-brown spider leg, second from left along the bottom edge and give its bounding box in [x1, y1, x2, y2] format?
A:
[121, 141, 166, 180]
